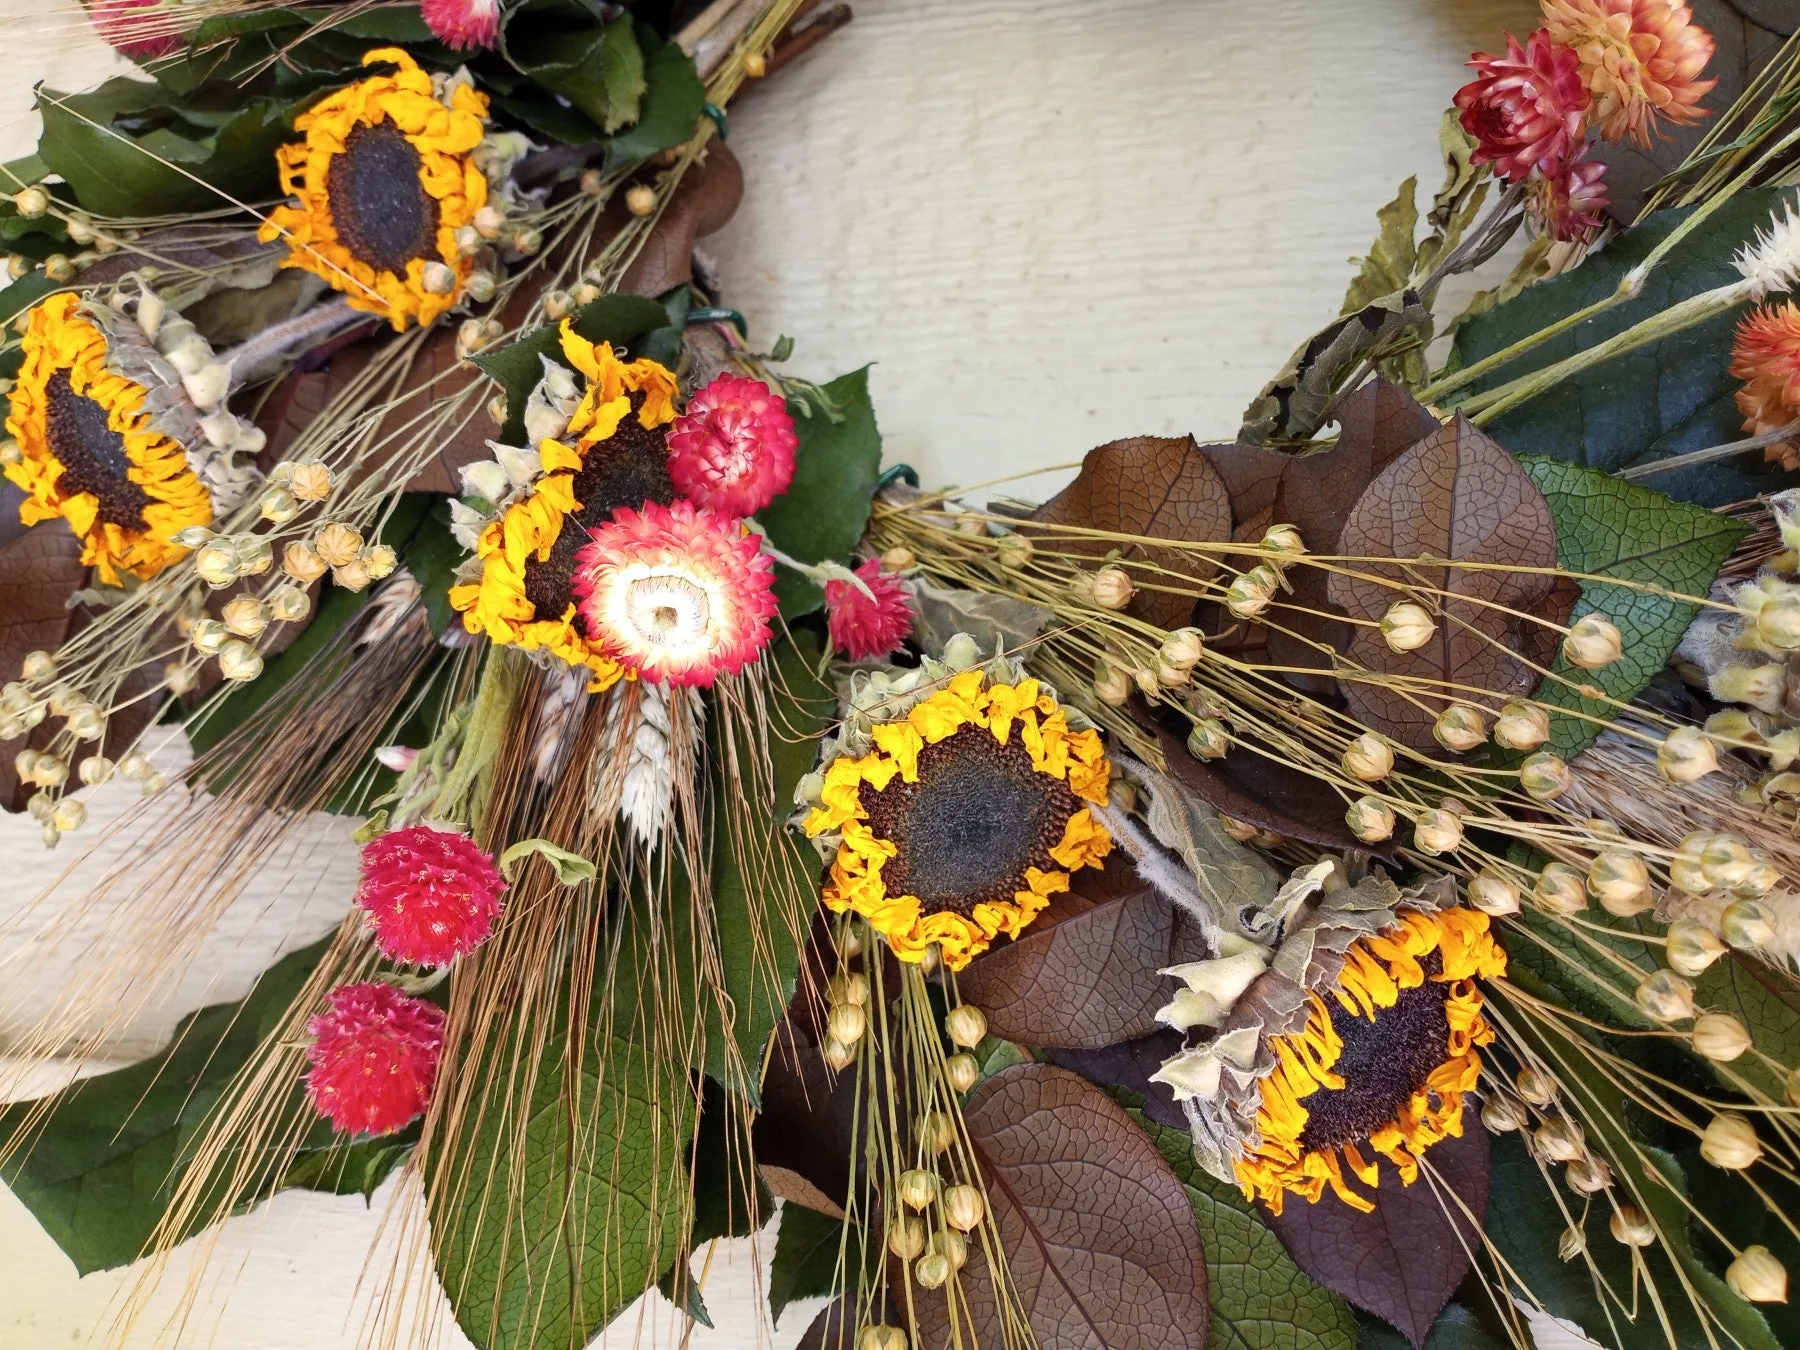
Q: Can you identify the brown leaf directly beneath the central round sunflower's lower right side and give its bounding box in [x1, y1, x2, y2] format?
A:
[956, 867, 1208, 1049]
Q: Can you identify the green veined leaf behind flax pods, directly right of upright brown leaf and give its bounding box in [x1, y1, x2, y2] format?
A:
[1519, 455, 1746, 760]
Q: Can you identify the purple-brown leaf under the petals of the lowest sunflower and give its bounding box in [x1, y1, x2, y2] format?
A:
[1264, 1111, 1487, 1346]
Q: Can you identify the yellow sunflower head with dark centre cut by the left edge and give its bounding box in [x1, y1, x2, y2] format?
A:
[5, 293, 212, 585]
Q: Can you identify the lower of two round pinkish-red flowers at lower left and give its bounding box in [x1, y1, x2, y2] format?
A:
[306, 983, 445, 1134]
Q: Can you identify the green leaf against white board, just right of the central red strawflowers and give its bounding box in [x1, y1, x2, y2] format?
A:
[756, 365, 882, 621]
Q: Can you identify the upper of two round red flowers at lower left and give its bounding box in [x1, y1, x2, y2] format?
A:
[356, 824, 506, 967]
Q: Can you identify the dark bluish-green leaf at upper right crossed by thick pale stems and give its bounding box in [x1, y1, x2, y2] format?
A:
[1449, 189, 1786, 506]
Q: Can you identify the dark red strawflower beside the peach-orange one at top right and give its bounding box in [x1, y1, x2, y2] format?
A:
[1456, 29, 1589, 182]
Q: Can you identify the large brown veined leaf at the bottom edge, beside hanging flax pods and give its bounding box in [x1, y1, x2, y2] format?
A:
[913, 1064, 1210, 1350]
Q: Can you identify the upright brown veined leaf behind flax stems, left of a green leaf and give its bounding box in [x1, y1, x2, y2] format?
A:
[1328, 416, 1557, 751]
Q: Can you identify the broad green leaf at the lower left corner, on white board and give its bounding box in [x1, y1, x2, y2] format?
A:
[0, 938, 329, 1274]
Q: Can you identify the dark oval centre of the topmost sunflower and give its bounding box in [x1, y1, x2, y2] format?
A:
[326, 121, 437, 272]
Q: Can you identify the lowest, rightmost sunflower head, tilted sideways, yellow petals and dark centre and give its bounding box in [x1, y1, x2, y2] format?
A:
[1237, 909, 1507, 1213]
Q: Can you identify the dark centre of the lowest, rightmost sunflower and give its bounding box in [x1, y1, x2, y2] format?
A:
[1300, 952, 1451, 1148]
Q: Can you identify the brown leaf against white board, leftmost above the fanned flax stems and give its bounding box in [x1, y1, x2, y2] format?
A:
[1031, 436, 1231, 628]
